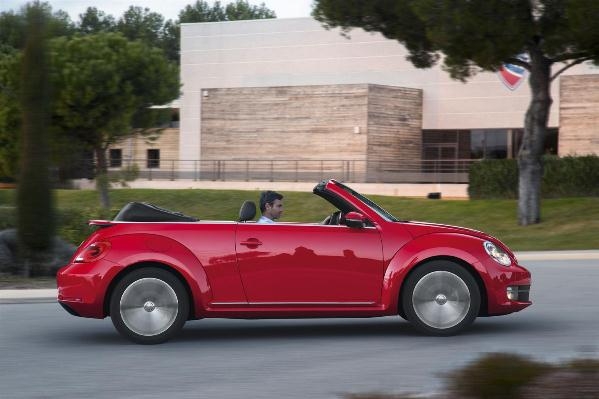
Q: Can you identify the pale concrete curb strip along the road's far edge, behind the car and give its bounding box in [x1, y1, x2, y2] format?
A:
[0, 250, 599, 304]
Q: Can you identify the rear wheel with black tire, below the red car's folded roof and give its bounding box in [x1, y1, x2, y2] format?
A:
[110, 267, 189, 345]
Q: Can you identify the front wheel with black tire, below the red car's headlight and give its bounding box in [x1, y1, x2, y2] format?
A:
[401, 260, 481, 336]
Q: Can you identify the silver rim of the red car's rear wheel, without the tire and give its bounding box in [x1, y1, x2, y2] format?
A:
[120, 278, 179, 337]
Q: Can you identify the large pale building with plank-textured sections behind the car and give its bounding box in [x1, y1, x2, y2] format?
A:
[110, 18, 599, 180]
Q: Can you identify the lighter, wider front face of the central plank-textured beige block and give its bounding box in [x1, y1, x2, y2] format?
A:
[201, 85, 368, 160]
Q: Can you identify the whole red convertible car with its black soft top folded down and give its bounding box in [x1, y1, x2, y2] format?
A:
[57, 180, 531, 344]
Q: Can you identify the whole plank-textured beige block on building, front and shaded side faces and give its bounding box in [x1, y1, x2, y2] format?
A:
[201, 84, 422, 178]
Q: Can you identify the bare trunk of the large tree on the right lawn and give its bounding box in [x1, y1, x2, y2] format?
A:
[518, 48, 553, 226]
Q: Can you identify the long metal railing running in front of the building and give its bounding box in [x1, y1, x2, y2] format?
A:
[103, 159, 478, 183]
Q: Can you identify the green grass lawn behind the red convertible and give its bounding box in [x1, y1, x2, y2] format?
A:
[0, 189, 599, 251]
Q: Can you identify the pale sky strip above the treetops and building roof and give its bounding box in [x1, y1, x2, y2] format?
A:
[0, 0, 312, 21]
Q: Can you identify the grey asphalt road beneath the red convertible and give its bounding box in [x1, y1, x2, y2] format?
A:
[0, 259, 599, 399]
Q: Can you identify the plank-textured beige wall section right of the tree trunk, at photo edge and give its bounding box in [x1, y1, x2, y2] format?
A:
[558, 75, 599, 156]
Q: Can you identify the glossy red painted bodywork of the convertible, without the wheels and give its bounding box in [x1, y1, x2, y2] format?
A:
[57, 180, 531, 319]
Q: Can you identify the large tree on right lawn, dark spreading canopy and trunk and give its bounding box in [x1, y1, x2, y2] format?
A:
[313, 0, 599, 225]
